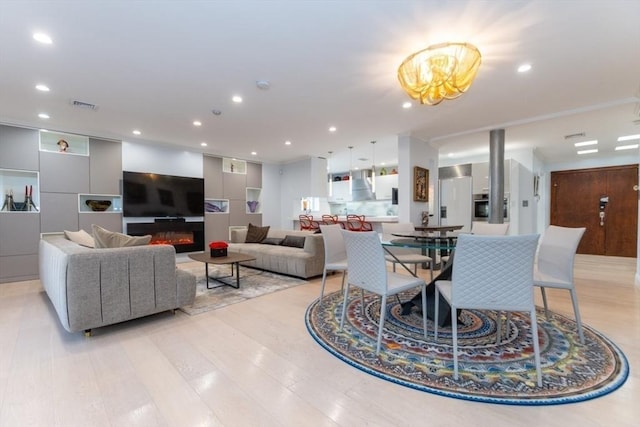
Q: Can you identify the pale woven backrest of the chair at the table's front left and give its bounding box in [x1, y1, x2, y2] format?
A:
[341, 230, 387, 294]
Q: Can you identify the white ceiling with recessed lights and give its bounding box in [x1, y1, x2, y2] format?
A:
[0, 0, 640, 170]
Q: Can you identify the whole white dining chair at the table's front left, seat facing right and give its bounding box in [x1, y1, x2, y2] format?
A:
[340, 230, 427, 355]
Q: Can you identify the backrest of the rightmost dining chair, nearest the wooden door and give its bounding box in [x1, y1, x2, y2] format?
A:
[538, 225, 585, 283]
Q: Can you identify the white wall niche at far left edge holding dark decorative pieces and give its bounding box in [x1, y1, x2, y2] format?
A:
[0, 169, 40, 213]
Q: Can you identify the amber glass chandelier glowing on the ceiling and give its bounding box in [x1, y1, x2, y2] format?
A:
[398, 43, 481, 105]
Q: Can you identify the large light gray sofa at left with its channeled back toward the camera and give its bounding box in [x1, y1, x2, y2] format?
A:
[39, 235, 196, 335]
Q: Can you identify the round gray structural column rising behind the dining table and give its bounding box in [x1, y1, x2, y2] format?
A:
[489, 129, 504, 224]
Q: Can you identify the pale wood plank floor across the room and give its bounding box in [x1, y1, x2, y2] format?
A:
[0, 256, 640, 427]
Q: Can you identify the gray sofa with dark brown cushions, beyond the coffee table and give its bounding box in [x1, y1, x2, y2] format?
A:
[228, 228, 324, 279]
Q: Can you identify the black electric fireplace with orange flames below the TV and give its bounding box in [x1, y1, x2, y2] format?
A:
[127, 219, 204, 253]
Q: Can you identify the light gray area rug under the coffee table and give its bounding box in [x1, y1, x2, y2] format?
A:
[178, 262, 307, 316]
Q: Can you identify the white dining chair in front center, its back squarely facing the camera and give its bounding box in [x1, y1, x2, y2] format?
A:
[434, 234, 542, 387]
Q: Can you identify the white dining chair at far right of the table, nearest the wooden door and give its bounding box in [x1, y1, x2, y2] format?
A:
[533, 225, 585, 344]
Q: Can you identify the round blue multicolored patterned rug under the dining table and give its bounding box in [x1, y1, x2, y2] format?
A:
[305, 290, 629, 405]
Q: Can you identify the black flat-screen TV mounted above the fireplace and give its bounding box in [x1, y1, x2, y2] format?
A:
[122, 171, 204, 218]
